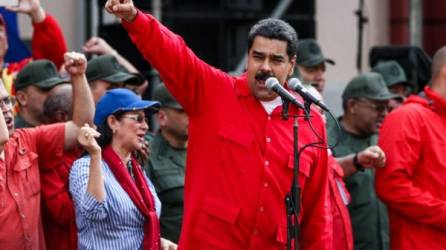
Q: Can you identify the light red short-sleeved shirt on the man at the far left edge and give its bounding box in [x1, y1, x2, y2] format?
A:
[0, 124, 64, 249]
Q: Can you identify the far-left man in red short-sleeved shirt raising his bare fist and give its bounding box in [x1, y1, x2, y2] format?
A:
[0, 53, 94, 249]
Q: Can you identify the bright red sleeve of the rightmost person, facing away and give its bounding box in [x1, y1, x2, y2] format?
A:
[376, 109, 446, 230]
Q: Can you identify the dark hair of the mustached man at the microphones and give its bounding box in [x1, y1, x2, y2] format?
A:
[248, 18, 297, 59]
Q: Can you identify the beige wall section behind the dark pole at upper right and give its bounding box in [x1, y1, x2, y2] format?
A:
[316, 0, 389, 114]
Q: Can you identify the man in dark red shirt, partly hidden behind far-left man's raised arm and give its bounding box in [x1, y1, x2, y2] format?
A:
[40, 83, 82, 250]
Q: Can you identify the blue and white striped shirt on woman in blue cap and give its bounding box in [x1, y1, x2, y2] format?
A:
[69, 156, 161, 250]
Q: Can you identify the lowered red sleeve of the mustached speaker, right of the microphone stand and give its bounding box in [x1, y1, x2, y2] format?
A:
[300, 116, 333, 249]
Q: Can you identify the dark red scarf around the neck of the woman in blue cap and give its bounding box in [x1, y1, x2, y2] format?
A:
[102, 146, 161, 250]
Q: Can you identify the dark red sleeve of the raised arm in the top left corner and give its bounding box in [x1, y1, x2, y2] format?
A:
[31, 13, 67, 69]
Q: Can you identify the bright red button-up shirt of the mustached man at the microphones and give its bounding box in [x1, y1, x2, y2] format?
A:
[123, 12, 332, 250]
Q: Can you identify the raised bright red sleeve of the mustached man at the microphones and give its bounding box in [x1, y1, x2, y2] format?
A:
[123, 11, 234, 116]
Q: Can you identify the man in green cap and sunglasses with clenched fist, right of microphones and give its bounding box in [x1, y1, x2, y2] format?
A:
[327, 73, 395, 250]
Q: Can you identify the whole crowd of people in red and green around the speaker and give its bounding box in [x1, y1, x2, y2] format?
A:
[0, 0, 446, 250]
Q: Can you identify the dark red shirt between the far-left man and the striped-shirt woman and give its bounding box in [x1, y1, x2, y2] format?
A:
[40, 149, 81, 250]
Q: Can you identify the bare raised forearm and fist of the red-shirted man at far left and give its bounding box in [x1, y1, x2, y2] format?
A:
[64, 52, 95, 151]
